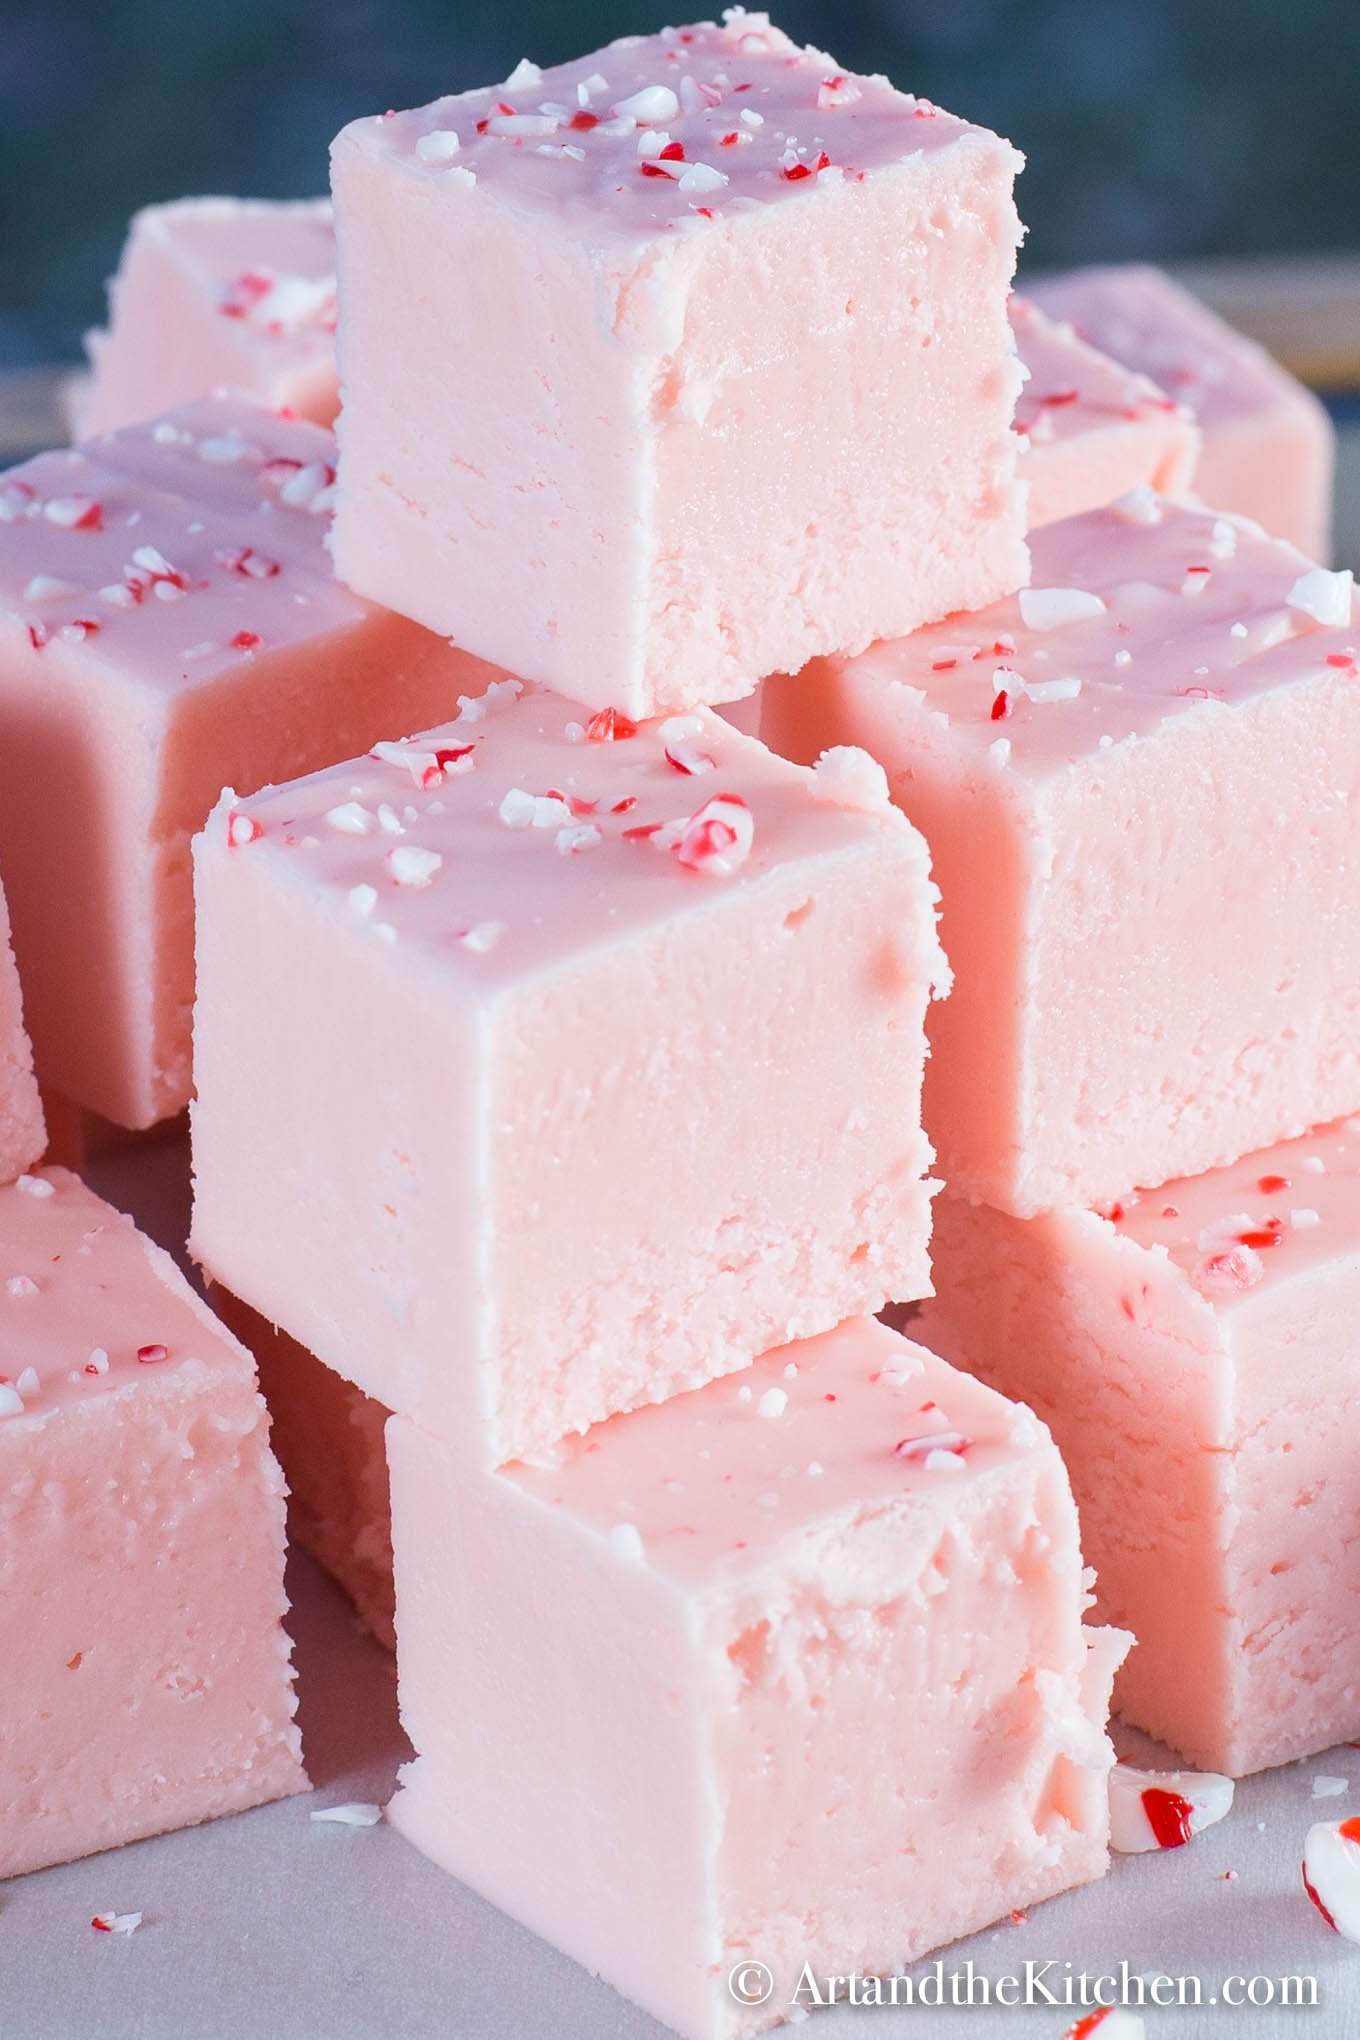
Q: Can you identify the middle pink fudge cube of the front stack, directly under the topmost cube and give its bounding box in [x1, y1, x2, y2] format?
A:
[192, 681, 944, 1465]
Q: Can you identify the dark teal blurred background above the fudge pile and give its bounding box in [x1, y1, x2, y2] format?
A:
[0, 0, 1360, 367]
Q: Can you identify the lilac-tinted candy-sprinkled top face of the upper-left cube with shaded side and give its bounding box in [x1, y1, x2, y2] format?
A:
[0, 396, 358, 690]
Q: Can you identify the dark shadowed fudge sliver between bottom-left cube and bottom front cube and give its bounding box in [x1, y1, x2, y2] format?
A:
[212, 1287, 396, 1650]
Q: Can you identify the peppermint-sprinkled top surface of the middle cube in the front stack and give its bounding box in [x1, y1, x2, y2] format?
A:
[208, 679, 948, 989]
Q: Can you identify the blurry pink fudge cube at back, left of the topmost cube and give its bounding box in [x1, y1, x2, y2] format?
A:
[73, 198, 341, 439]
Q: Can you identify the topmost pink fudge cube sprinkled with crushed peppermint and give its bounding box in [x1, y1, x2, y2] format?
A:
[332, 8, 1026, 716]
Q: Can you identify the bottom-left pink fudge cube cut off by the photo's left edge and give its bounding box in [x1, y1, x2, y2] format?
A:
[0, 1169, 306, 1877]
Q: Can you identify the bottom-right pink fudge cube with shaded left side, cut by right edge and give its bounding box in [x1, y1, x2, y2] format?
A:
[913, 1120, 1360, 1777]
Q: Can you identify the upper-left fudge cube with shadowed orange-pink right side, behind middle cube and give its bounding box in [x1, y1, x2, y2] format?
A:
[0, 398, 505, 1126]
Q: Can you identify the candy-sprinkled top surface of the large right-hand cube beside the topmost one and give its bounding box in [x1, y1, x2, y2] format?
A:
[835, 488, 1360, 779]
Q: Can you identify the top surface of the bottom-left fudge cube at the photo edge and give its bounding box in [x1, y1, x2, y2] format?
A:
[0, 1169, 255, 1434]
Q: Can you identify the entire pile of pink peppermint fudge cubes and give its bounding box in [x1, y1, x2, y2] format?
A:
[0, 10, 1360, 2036]
